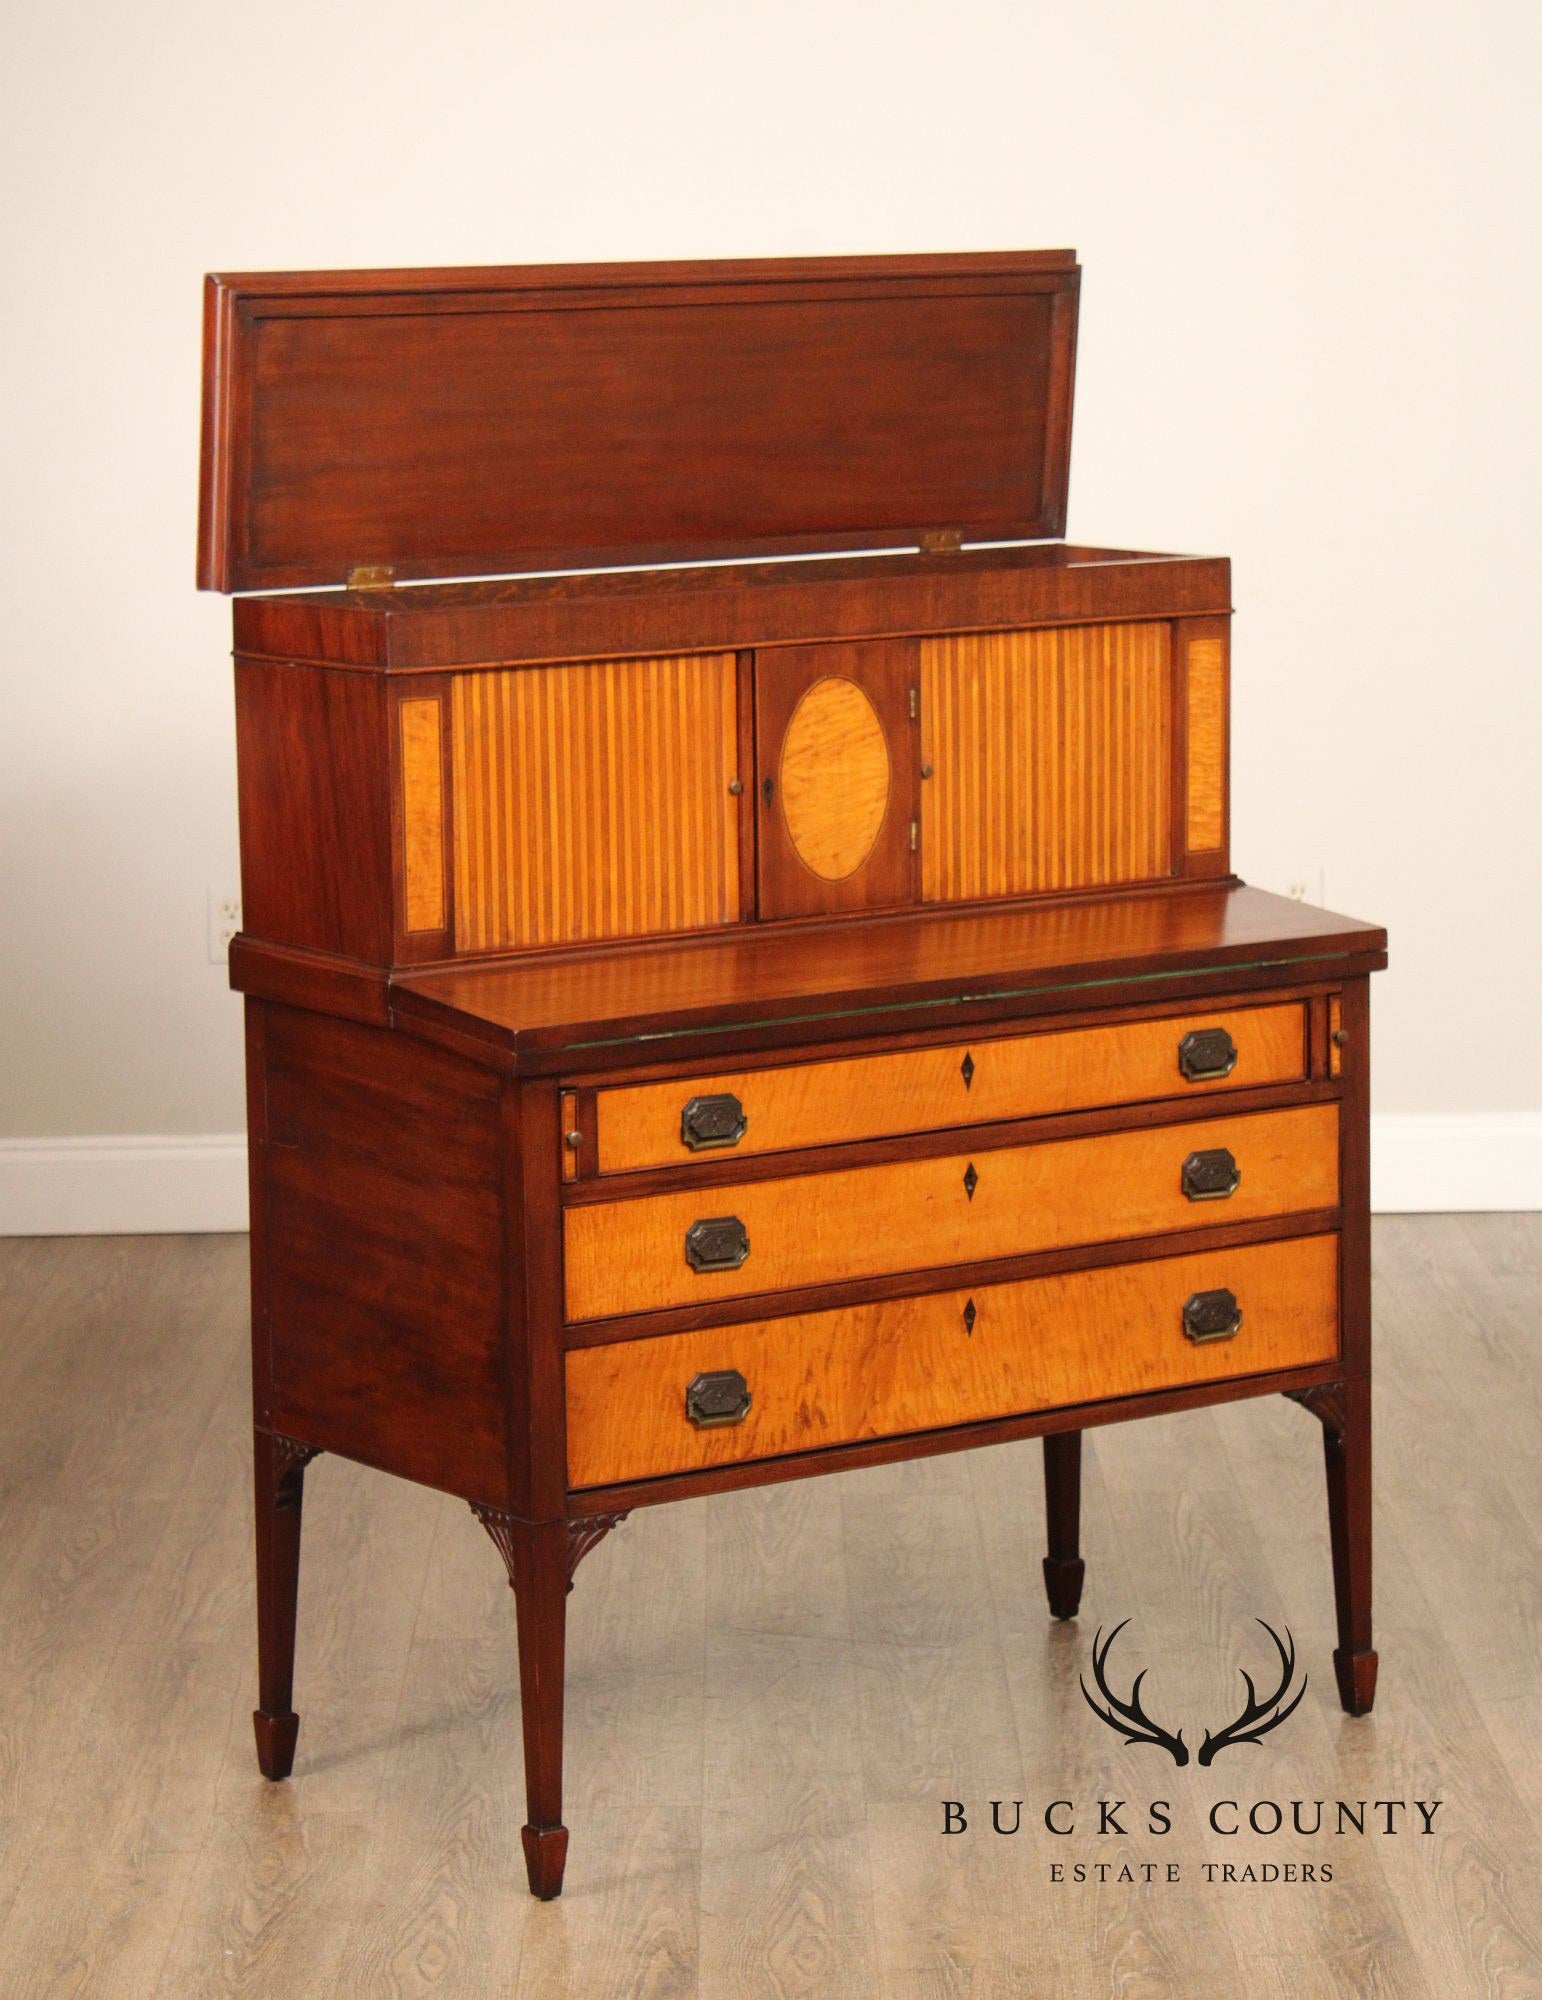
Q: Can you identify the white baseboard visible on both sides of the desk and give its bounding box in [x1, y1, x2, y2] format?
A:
[0, 1112, 1542, 1236]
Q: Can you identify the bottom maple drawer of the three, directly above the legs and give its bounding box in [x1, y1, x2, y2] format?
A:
[568, 1236, 1338, 1486]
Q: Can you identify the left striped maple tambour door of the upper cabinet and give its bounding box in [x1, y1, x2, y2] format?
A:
[452, 654, 738, 952]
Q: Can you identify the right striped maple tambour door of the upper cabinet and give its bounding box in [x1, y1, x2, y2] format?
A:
[920, 622, 1172, 902]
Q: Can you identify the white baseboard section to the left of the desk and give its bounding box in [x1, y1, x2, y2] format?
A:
[0, 1132, 246, 1236]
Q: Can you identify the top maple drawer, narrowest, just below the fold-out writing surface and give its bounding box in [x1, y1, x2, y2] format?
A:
[596, 1000, 1306, 1174]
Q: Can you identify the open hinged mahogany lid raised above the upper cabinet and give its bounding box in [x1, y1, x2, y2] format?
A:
[198, 250, 1080, 590]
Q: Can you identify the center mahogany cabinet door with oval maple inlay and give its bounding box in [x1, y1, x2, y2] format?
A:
[754, 640, 920, 918]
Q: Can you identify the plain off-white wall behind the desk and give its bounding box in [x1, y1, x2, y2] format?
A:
[0, 0, 1542, 1216]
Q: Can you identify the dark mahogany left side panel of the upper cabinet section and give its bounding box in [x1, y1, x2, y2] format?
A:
[236, 660, 392, 964]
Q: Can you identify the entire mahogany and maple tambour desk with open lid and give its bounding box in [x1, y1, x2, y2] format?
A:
[198, 252, 1386, 1896]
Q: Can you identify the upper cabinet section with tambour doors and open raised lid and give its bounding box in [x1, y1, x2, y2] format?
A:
[211, 250, 1230, 996]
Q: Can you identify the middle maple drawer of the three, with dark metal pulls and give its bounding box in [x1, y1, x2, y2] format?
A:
[564, 1104, 1338, 1320]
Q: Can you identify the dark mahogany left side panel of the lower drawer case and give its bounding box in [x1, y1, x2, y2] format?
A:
[262, 1008, 508, 1502]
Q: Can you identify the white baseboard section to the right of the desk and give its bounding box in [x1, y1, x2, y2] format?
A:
[1370, 1112, 1542, 1216]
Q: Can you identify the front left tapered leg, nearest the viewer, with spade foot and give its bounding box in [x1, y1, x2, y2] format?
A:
[472, 1506, 572, 1902]
